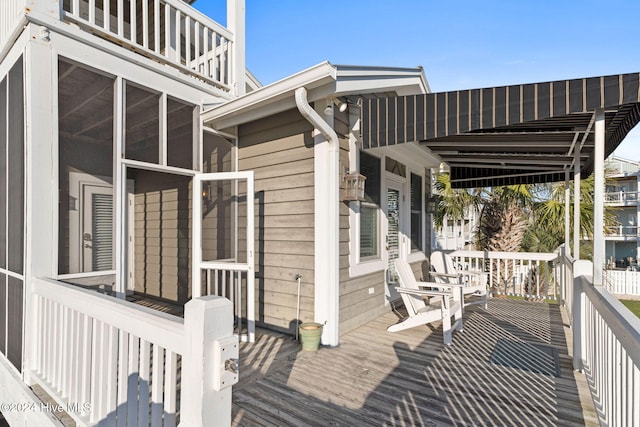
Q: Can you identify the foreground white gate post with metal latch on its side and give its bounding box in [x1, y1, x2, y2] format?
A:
[180, 296, 238, 427]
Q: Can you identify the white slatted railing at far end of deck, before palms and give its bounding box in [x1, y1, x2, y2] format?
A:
[450, 251, 563, 300]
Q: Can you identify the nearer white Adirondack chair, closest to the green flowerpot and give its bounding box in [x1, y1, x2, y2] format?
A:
[387, 259, 462, 345]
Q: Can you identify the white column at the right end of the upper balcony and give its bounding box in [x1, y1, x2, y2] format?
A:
[227, 0, 247, 96]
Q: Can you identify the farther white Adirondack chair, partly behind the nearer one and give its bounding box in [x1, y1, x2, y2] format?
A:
[430, 251, 488, 310]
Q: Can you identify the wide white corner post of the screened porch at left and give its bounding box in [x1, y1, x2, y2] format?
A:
[23, 25, 58, 384]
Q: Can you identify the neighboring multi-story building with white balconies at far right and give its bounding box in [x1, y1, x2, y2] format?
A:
[605, 156, 640, 268]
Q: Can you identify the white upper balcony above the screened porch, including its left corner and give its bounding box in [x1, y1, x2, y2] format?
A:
[0, 0, 236, 92]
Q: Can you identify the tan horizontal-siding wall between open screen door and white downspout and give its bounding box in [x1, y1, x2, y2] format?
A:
[238, 110, 315, 333]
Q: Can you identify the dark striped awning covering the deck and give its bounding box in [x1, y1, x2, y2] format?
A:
[361, 73, 640, 187]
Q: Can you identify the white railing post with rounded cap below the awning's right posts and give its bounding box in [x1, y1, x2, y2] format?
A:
[571, 261, 593, 372]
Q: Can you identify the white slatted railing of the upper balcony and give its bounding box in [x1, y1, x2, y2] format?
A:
[60, 0, 234, 91]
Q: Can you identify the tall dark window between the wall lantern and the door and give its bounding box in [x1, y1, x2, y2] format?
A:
[358, 152, 381, 259]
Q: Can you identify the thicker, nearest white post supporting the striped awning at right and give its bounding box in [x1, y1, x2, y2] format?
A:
[593, 108, 605, 286]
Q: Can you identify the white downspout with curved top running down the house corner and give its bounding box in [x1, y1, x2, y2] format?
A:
[295, 87, 340, 347]
